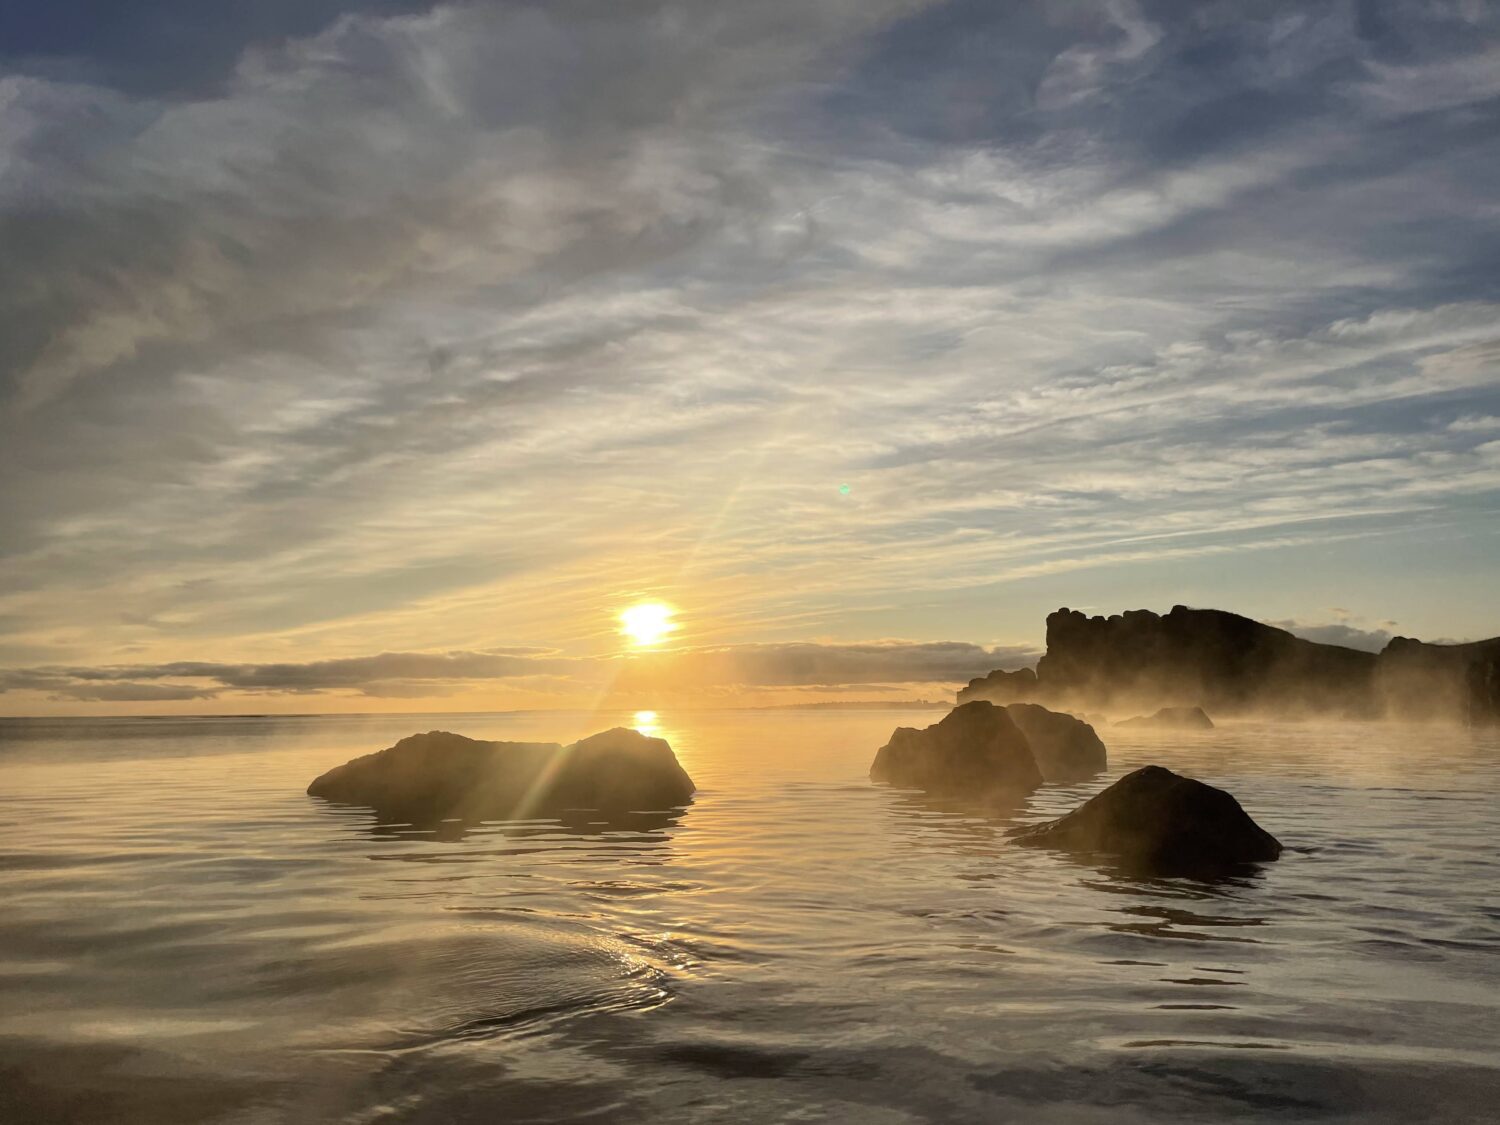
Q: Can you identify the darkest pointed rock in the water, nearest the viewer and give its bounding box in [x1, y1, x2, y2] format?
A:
[1011, 765, 1281, 875]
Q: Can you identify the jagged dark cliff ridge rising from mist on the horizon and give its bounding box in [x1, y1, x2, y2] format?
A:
[959, 606, 1500, 723]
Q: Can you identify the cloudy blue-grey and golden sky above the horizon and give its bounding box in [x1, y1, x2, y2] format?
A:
[0, 0, 1500, 714]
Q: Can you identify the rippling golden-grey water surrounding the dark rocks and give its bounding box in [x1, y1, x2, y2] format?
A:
[0, 713, 1500, 1125]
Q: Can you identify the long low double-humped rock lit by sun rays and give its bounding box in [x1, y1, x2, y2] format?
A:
[308, 728, 693, 825]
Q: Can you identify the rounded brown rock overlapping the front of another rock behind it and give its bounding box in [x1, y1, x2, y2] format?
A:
[870, 699, 1043, 797]
